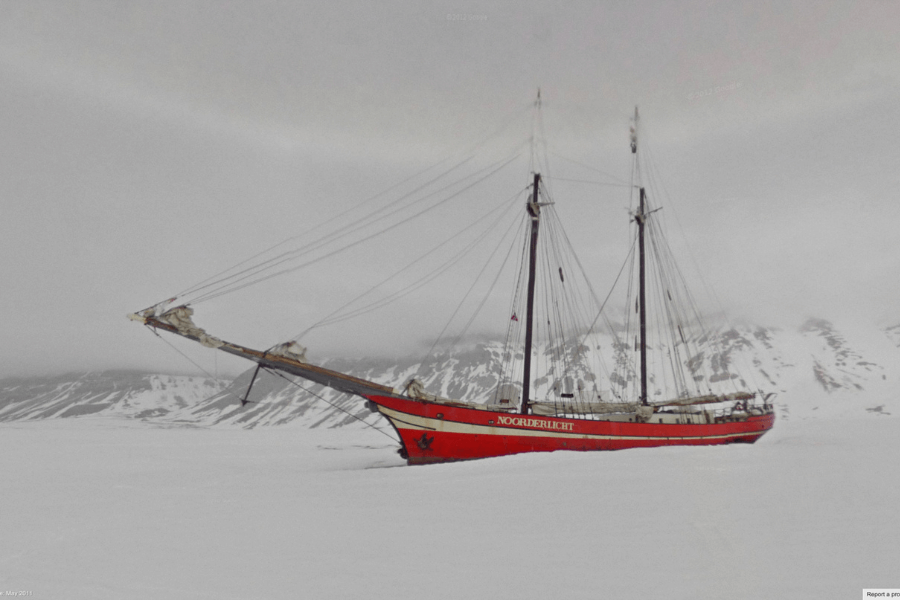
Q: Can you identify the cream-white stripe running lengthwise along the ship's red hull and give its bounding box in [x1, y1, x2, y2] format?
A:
[378, 405, 765, 440]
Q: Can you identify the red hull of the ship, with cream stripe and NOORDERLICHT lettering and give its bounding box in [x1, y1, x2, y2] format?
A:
[368, 395, 775, 464]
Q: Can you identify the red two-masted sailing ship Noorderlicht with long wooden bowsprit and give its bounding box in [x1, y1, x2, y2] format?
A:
[129, 95, 775, 464]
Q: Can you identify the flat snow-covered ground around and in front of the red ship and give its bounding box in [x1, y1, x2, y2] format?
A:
[0, 414, 900, 600]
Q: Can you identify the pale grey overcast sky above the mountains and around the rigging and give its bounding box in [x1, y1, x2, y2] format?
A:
[0, 0, 900, 376]
